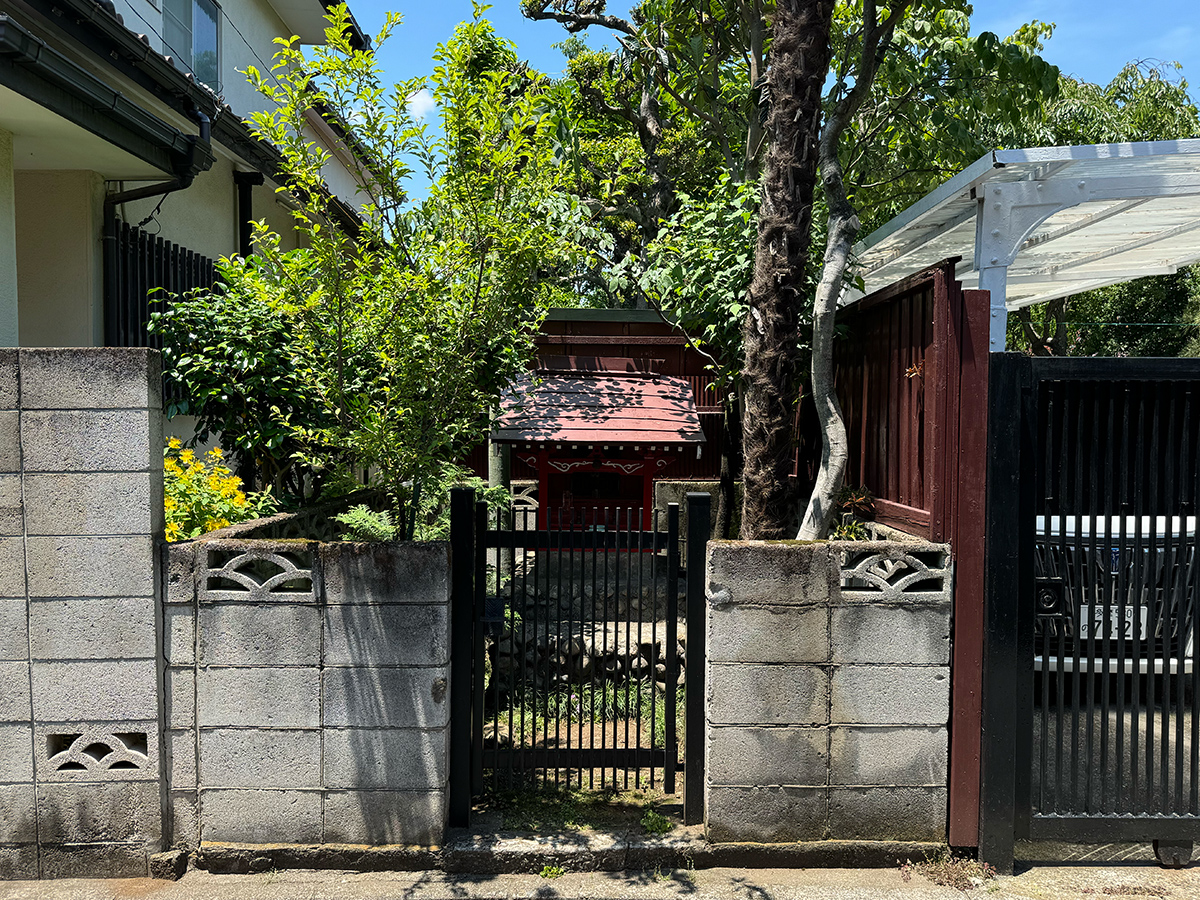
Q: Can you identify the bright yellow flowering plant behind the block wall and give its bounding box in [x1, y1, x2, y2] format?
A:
[162, 438, 276, 541]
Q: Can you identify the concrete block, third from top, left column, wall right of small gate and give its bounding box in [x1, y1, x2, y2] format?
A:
[706, 664, 829, 725]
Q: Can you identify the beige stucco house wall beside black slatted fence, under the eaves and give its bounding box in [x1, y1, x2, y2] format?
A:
[16, 170, 104, 347]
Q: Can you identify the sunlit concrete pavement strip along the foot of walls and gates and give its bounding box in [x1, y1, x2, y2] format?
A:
[0, 862, 1200, 900]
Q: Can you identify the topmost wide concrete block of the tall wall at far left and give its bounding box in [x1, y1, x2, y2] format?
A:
[20, 347, 162, 409]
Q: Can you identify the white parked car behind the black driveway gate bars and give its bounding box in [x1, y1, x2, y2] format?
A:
[1033, 516, 1200, 674]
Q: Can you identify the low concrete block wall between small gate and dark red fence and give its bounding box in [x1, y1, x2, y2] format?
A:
[704, 541, 952, 842]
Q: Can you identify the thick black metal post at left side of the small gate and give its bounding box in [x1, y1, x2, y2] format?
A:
[450, 487, 475, 828]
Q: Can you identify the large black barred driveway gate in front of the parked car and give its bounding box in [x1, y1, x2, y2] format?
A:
[980, 354, 1200, 868]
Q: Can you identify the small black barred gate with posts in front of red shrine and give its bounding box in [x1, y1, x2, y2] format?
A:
[450, 490, 710, 823]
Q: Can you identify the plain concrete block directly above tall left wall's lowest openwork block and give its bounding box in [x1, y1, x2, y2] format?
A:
[31, 659, 158, 722]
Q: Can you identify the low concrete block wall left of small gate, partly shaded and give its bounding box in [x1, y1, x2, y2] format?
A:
[163, 539, 450, 846]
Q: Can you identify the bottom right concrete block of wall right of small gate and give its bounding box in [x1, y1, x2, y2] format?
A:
[829, 787, 947, 842]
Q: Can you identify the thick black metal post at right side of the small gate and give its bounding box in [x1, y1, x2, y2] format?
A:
[683, 493, 713, 824]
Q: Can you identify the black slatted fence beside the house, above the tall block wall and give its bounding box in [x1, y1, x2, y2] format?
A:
[104, 222, 216, 350]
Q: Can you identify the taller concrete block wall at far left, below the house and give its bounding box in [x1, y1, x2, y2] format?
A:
[0, 349, 162, 878]
